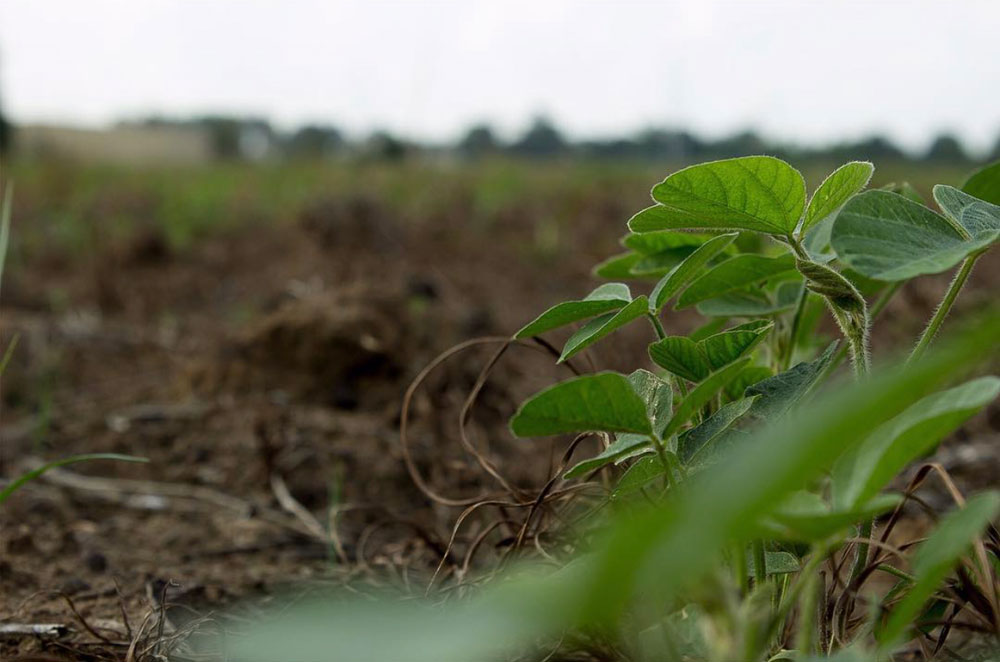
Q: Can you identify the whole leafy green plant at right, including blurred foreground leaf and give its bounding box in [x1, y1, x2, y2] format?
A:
[229, 156, 1000, 662]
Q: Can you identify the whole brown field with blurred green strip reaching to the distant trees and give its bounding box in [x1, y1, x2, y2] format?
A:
[0, 161, 1000, 660]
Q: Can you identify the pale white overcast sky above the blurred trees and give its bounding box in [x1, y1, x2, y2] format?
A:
[0, 0, 1000, 149]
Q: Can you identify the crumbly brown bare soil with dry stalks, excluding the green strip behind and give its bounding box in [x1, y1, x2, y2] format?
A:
[0, 184, 1000, 660]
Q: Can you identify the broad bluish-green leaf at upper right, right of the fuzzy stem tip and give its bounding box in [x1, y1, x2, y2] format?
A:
[830, 191, 1000, 281]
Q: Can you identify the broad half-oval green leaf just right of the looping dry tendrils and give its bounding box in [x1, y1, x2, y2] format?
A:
[510, 372, 653, 437]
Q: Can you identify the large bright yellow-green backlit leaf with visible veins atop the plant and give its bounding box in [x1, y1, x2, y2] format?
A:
[629, 156, 806, 235]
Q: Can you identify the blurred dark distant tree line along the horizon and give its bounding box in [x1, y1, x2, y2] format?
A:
[7, 115, 1000, 163]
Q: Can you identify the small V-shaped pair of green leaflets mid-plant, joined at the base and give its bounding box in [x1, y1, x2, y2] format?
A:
[649, 320, 774, 382]
